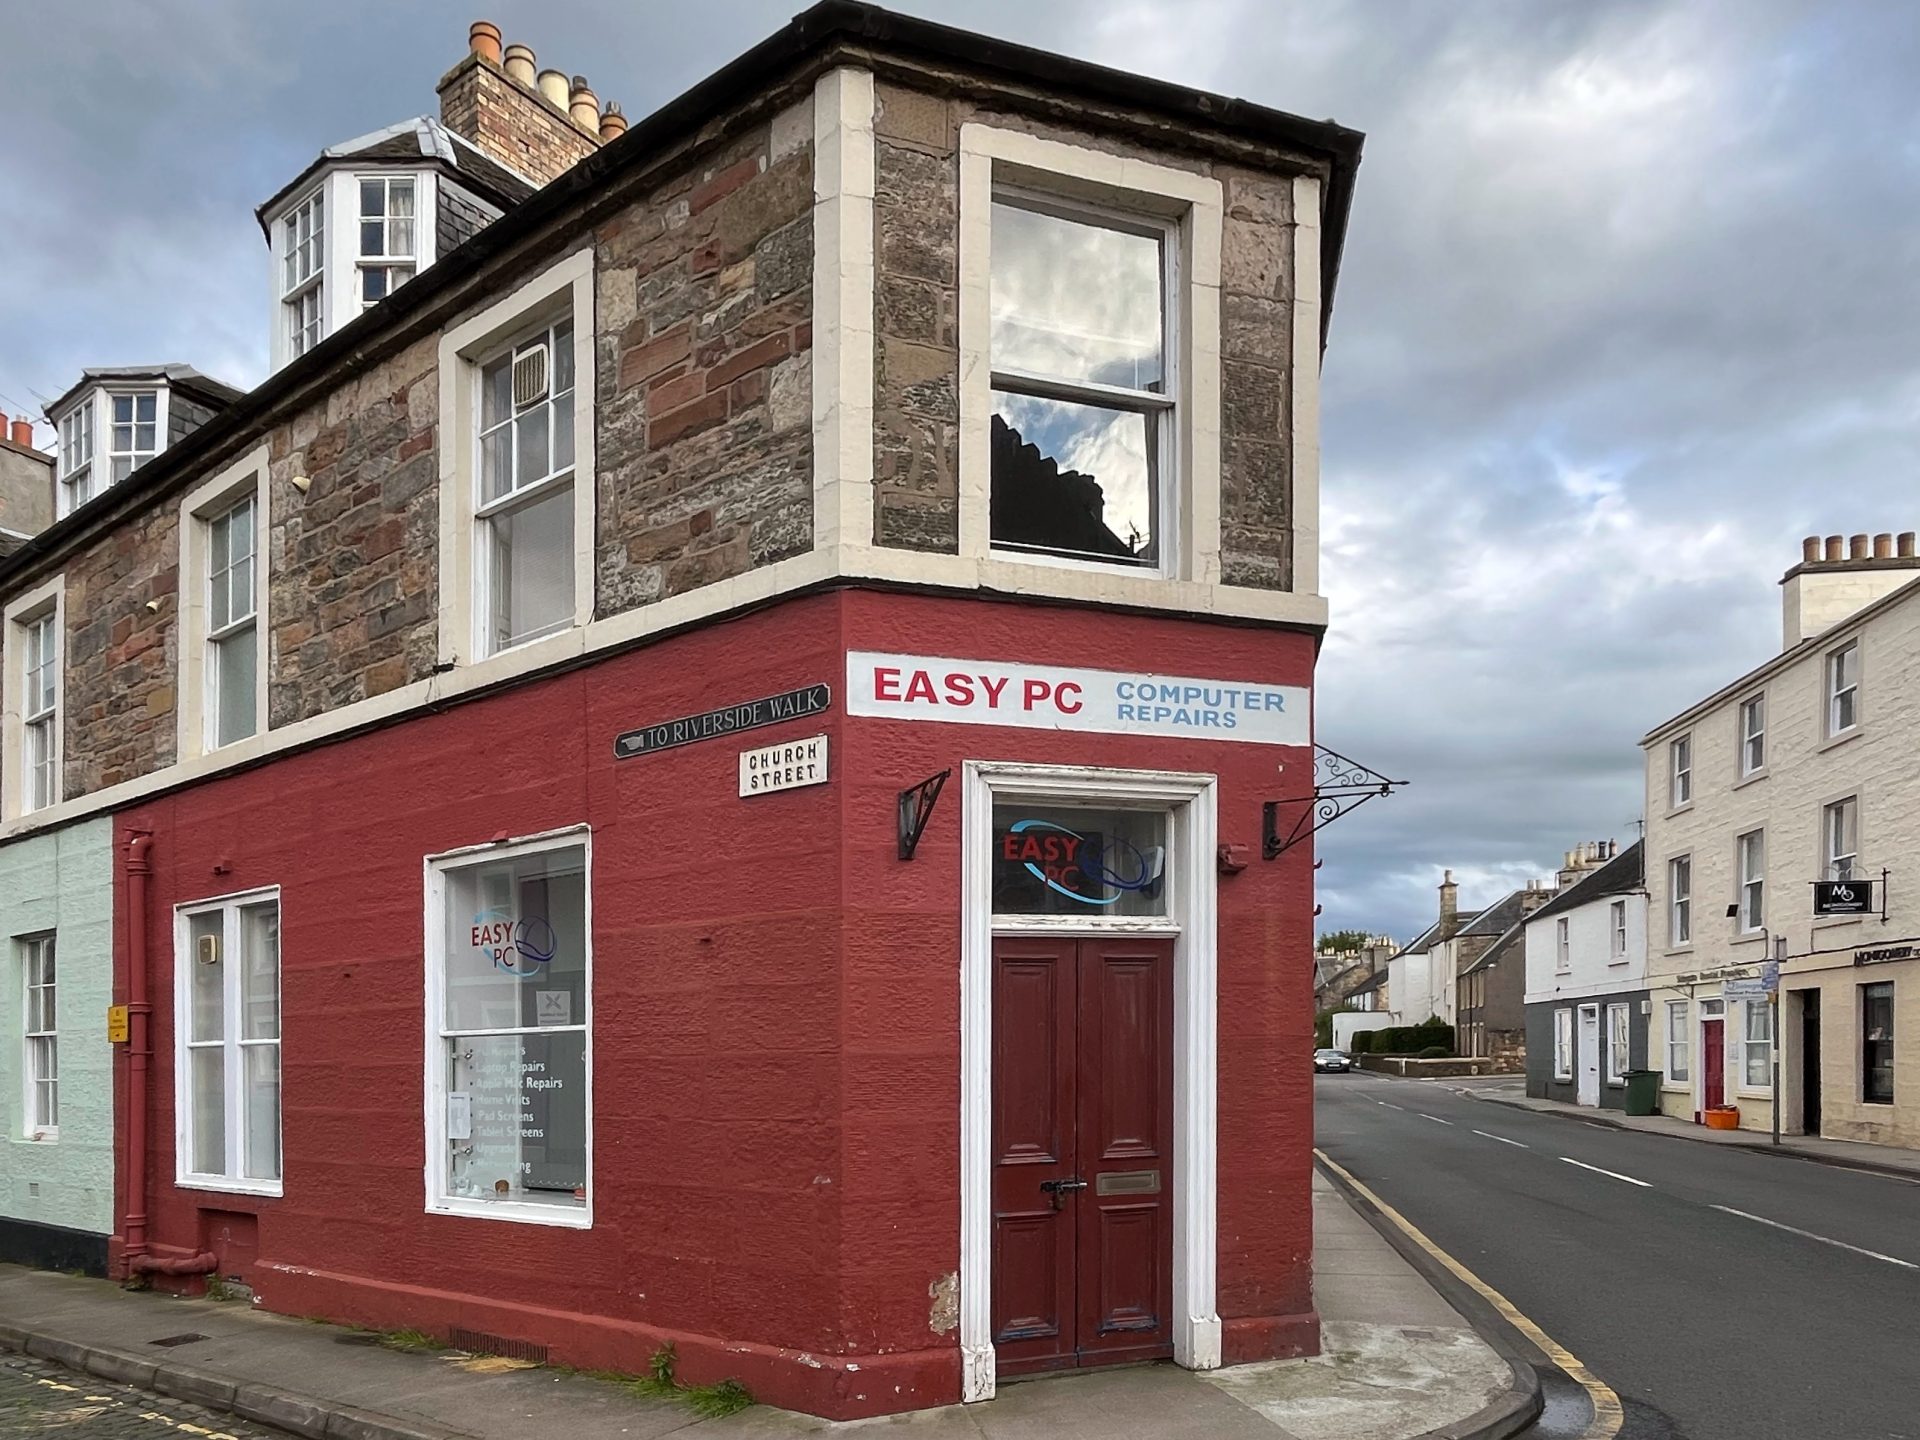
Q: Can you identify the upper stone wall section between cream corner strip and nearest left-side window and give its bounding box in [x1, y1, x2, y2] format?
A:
[595, 127, 814, 616]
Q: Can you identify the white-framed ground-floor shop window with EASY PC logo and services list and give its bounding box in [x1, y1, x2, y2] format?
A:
[426, 835, 591, 1227]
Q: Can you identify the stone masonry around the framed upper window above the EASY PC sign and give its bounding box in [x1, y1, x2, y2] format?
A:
[874, 83, 1294, 589]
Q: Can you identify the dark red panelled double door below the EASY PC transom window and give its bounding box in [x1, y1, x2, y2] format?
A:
[993, 937, 1173, 1375]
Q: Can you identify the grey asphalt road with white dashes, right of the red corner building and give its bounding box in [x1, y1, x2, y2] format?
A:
[1315, 1073, 1920, 1440]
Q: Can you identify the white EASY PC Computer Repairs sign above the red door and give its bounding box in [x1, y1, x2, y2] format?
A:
[847, 651, 1313, 745]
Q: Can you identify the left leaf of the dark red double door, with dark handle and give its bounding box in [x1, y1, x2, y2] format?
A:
[993, 939, 1079, 1373]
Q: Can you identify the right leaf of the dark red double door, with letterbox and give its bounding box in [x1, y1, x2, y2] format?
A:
[1075, 939, 1173, 1363]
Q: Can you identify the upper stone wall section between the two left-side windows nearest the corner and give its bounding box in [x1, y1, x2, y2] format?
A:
[267, 340, 440, 726]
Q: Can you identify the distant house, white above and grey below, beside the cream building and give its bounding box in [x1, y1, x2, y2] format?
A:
[1524, 841, 1649, 1110]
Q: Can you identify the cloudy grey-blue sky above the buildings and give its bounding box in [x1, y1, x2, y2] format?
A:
[0, 0, 1920, 939]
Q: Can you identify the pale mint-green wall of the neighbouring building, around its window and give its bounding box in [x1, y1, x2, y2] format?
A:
[0, 820, 113, 1235]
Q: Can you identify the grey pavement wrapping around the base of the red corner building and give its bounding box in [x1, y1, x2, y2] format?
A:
[0, 1175, 1540, 1440]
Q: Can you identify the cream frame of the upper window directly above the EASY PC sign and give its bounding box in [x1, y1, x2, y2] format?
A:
[958, 123, 1228, 591]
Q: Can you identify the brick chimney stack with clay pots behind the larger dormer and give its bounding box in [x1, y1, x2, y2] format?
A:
[440, 19, 606, 184]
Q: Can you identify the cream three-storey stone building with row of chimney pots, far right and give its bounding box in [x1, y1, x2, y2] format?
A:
[1642, 534, 1920, 1146]
